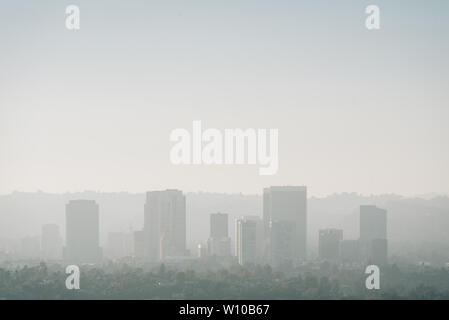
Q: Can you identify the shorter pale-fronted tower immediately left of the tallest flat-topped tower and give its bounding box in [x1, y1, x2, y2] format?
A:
[235, 216, 264, 265]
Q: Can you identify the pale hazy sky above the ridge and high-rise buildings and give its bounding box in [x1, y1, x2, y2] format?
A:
[0, 0, 449, 195]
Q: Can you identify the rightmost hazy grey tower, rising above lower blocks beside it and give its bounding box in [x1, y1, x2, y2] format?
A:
[360, 205, 388, 264]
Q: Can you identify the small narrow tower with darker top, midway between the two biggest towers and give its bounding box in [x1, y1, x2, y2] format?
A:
[207, 212, 231, 257]
